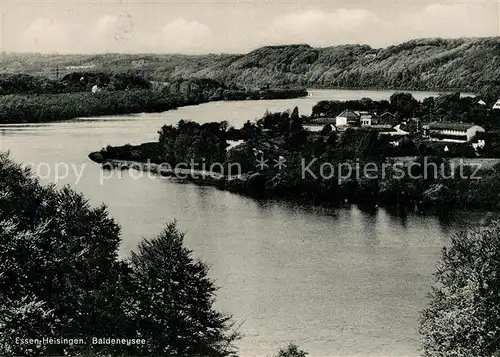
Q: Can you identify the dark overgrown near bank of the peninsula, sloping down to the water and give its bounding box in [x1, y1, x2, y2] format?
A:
[89, 145, 500, 212]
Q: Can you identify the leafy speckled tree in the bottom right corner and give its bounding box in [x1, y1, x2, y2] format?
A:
[420, 221, 500, 357]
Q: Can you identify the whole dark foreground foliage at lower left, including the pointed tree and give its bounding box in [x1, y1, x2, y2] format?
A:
[0, 154, 237, 356]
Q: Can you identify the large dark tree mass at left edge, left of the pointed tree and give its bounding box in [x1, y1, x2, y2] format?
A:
[0, 154, 126, 355]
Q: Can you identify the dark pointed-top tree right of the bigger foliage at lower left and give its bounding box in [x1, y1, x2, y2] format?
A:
[130, 223, 237, 356]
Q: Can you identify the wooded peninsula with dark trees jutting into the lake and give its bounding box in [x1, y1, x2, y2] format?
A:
[90, 93, 500, 210]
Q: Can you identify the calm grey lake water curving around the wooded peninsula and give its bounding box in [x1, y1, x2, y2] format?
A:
[0, 90, 480, 356]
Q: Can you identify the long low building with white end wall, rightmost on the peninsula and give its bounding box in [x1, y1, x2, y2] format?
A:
[426, 123, 485, 143]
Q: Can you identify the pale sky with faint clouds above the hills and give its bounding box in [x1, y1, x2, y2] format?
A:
[0, 0, 500, 54]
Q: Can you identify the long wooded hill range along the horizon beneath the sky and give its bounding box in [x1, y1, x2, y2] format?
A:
[0, 37, 500, 92]
